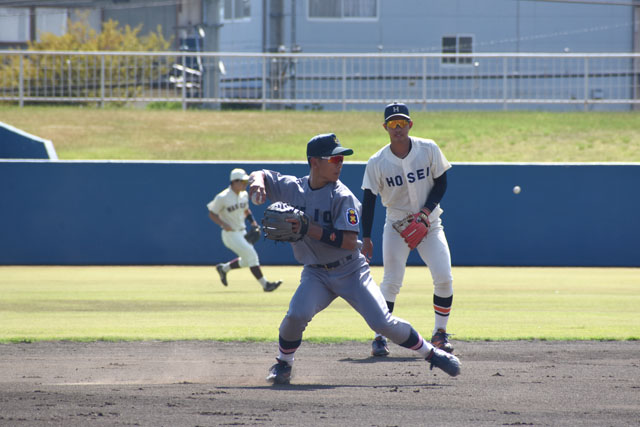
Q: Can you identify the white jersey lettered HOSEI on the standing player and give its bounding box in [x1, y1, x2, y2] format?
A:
[362, 137, 451, 223]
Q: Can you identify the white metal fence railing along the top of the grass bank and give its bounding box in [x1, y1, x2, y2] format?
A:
[0, 50, 640, 109]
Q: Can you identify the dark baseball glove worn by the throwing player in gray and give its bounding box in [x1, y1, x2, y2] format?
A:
[262, 202, 309, 242]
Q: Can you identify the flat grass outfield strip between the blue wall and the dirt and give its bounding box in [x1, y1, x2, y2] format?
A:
[0, 266, 640, 342]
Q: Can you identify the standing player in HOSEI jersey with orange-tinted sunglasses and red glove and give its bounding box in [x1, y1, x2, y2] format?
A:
[362, 103, 453, 356]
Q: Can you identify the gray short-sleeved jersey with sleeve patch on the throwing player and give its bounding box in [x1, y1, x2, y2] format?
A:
[264, 170, 361, 265]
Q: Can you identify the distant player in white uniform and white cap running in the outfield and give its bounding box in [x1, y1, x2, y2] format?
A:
[207, 168, 282, 292]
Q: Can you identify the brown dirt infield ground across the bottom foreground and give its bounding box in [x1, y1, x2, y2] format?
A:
[0, 341, 640, 426]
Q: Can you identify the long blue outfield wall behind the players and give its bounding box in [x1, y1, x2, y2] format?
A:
[0, 161, 640, 266]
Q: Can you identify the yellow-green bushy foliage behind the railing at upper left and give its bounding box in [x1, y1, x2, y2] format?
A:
[0, 16, 172, 104]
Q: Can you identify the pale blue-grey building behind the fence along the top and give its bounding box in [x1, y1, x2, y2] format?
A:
[0, 0, 640, 109]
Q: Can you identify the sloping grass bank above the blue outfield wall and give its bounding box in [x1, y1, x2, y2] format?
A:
[0, 105, 640, 162]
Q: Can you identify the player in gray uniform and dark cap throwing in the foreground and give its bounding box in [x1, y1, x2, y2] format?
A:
[249, 134, 460, 384]
